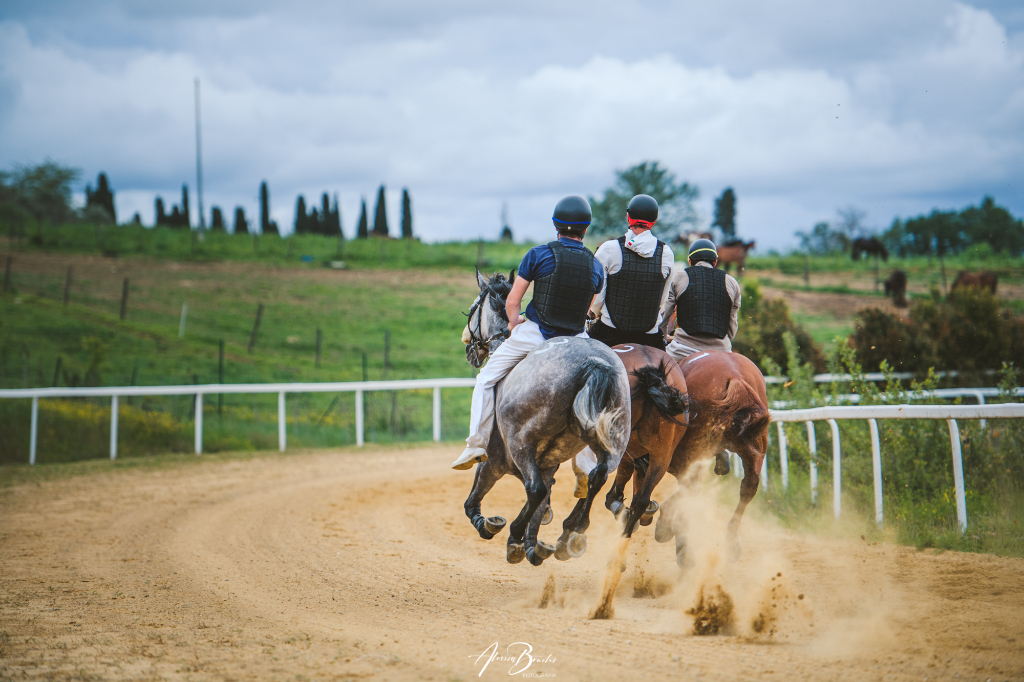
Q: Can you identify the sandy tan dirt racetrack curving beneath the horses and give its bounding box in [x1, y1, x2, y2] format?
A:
[0, 445, 1024, 681]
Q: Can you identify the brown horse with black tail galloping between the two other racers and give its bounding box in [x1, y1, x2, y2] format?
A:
[604, 344, 689, 538]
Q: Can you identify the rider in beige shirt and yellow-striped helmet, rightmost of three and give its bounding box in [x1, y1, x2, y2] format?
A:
[662, 240, 741, 360]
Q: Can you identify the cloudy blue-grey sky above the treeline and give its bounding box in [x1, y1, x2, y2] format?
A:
[0, 0, 1024, 248]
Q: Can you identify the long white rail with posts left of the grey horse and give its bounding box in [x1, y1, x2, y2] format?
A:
[0, 378, 476, 464]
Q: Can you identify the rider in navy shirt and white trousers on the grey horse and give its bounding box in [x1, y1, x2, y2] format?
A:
[452, 196, 604, 469]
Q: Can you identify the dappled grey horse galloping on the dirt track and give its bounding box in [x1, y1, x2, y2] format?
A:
[464, 272, 630, 566]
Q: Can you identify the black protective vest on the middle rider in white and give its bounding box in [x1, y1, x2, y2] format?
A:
[604, 237, 666, 334]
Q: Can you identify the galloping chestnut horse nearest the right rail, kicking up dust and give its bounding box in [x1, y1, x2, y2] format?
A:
[655, 350, 771, 566]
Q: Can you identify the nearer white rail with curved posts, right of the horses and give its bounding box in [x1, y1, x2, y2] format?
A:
[762, 402, 1024, 532]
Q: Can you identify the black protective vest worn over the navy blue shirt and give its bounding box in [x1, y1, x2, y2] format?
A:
[534, 242, 594, 335]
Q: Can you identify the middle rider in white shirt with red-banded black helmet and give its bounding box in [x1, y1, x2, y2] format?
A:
[589, 195, 676, 350]
